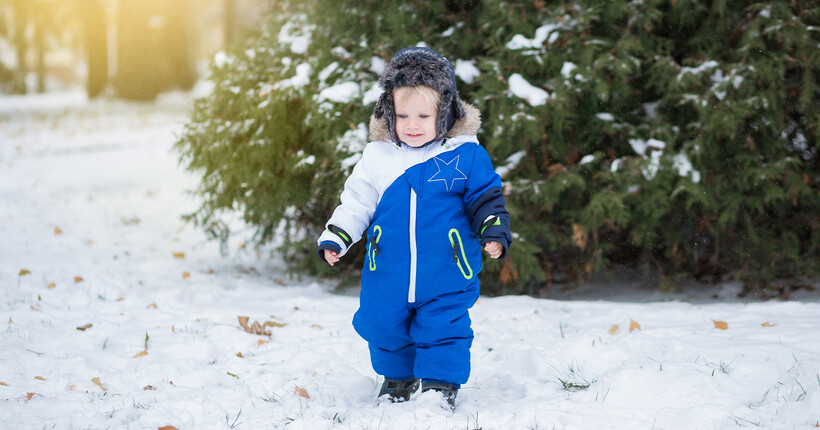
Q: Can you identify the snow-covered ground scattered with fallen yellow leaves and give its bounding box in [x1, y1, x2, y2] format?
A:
[0, 92, 820, 430]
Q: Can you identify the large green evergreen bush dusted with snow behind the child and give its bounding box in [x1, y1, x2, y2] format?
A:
[177, 0, 820, 294]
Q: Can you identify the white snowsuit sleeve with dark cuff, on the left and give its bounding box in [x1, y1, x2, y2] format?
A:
[317, 146, 379, 261]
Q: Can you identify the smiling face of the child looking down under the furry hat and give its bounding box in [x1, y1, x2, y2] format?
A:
[393, 87, 438, 148]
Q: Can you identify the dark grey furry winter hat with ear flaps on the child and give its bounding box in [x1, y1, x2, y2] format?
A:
[373, 47, 466, 143]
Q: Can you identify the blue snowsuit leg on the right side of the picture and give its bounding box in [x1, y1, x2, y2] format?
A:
[410, 288, 478, 385]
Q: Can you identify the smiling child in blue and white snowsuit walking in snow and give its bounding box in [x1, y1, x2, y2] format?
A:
[318, 48, 512, 408]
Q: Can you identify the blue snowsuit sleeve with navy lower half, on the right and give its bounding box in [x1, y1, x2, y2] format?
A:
[464, 146, 512, 258]
